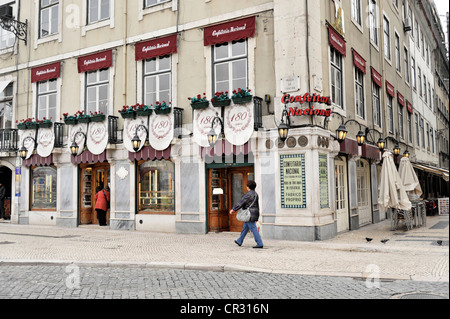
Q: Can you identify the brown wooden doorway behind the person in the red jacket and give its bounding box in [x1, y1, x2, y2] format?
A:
[79, 163, 110, 225]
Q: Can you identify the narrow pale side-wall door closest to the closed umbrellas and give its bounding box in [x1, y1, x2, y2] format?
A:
[356, 160, 372, 226]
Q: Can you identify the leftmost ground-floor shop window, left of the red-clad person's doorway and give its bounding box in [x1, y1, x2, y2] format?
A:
[30, 166, 57, 210]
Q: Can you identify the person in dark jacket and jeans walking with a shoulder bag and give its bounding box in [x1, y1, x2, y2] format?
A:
[230, 181, 264, 248]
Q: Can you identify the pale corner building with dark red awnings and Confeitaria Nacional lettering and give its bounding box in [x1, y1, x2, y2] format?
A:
[0, 0, 448, 241]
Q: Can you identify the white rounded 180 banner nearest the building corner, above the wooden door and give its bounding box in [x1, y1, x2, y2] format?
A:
[224, 103, 254, 146]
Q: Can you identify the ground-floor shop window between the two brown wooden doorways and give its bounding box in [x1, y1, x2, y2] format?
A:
[137, 160, 175, 214]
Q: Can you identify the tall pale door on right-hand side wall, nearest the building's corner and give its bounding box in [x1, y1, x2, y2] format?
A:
[334, 160, 350, 233]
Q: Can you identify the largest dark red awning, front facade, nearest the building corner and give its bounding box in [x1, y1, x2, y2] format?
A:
[203, 16, 256, 46]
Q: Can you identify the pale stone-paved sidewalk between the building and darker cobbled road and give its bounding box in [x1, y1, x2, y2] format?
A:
[0, 216, 449, 282]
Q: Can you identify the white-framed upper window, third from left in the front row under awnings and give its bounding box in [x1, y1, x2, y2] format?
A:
[143, 55, 172, 105]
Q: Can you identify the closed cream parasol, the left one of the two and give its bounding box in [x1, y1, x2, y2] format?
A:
[378, 151, 411, 211]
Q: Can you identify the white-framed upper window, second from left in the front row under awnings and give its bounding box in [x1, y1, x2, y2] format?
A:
[85, 69, 109, 115]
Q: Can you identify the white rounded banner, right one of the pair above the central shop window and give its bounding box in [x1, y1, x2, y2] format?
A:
[148, 112, 174, 151]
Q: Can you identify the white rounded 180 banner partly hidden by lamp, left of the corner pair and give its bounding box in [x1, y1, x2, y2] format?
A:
[192, 106, 221, 147]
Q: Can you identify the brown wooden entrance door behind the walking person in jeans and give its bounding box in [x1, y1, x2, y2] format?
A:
[207, 167, 254, 232]
